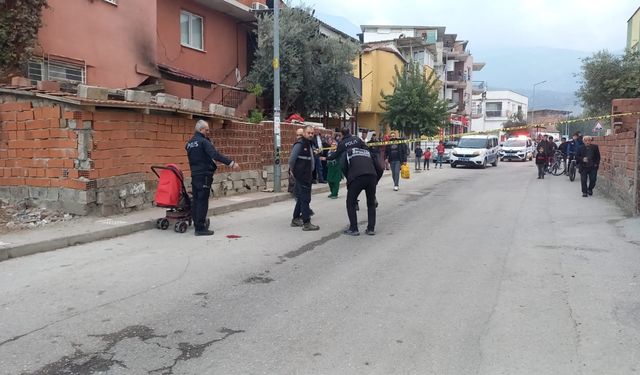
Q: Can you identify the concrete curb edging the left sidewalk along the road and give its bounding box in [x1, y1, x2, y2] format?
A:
[0, 185, 329, 262]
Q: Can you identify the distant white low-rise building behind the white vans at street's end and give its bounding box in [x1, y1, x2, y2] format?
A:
[471, 90, 529, 132]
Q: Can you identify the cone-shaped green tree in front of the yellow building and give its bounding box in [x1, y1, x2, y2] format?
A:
[380, 62, 449, 136]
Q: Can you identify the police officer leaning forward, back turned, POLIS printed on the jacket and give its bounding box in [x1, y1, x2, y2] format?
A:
[344, 140, 384, 236]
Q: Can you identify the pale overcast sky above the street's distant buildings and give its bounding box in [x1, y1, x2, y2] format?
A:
[308, 0, 640, 52]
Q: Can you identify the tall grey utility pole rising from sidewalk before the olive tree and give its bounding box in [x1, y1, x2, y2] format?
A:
[273, 0, 282, 193]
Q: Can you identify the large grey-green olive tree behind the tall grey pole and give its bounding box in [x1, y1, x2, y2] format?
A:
[248, 7, 357, 117]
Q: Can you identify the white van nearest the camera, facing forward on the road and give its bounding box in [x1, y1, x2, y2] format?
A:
[451, 135, 500, 168]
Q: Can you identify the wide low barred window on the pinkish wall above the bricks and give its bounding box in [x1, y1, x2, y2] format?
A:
[27, 58, 86, 83]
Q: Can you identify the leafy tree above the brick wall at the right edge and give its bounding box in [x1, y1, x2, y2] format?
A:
[576, 51, 640, 116]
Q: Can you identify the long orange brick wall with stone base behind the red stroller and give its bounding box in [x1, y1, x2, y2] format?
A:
[0, 95, 331, 215]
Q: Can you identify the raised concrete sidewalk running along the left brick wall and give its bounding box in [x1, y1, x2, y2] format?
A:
[0, 181, 336, 261]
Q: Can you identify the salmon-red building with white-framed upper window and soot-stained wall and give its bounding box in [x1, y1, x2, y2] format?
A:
[27, 0, 267, 116]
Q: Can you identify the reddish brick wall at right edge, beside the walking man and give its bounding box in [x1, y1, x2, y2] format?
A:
[594, 130, 640, 215]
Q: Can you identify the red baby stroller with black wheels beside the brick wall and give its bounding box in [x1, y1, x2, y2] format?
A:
[151, 164, 209, 233]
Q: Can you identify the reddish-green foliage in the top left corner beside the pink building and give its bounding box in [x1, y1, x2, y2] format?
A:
[0, 0, 47, 81]
